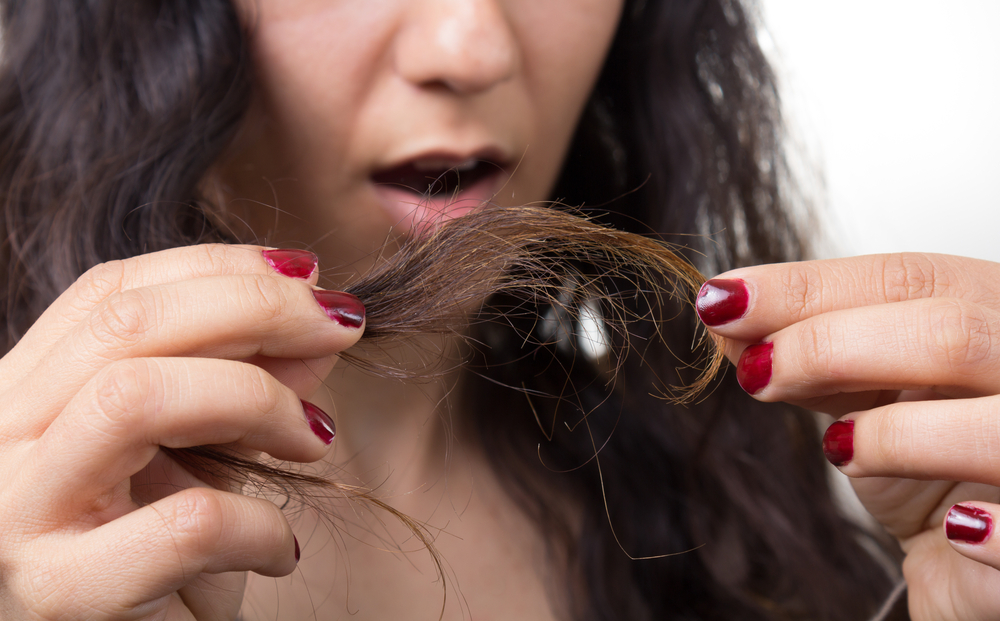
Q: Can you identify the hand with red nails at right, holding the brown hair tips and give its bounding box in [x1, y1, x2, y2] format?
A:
[698, 254, 1000, 621]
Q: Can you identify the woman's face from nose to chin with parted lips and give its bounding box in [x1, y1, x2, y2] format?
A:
[219, 0, 623, 268]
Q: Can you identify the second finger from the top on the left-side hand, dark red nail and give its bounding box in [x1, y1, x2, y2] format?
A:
[8, 275, 364, 434]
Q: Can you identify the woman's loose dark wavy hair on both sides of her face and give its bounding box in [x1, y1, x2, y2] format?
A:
[0, 0, 889, 620]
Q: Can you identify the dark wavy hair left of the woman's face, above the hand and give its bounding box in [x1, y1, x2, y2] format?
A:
[0, 0, 251, 348]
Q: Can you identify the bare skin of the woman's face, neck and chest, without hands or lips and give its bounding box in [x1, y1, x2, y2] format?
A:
[220, 0, 621, 619]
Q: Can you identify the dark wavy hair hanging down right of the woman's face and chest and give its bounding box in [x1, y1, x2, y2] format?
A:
[465, 0, 904, 621]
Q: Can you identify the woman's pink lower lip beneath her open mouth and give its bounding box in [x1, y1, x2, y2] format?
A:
[375, 171, 507, 234]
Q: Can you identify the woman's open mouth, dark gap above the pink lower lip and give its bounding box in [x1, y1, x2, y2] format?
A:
[372, 159, 503, 198]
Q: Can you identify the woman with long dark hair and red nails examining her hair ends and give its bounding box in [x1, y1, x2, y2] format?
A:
[0, 0, 996, 619]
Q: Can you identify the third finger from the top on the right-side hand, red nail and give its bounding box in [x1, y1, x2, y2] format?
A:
[823, 396, 1000, 486]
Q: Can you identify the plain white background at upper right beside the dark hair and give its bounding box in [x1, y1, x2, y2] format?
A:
[761, 0, 1000, 261]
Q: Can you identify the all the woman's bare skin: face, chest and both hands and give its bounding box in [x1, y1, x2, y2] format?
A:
[0, 0, 1000, 619]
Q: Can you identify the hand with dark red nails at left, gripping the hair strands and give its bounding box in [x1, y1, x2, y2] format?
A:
[0, 245, 364, 619]
